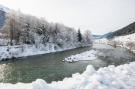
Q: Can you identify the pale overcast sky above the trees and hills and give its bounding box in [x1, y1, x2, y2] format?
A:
[0, 0, 135, 34]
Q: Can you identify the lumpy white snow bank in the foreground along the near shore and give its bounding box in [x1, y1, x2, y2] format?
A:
[0, 62, 135, 89]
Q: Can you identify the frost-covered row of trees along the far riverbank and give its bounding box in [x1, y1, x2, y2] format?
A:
[2, 11, 92, 47]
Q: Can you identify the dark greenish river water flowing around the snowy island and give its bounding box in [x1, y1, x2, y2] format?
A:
[0, 44, 135, 83]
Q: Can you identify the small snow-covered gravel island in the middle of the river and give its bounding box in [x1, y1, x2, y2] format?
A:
[64, 50, 97, 62]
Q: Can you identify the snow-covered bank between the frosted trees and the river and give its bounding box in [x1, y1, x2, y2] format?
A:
[0, 43, 89, 61]
